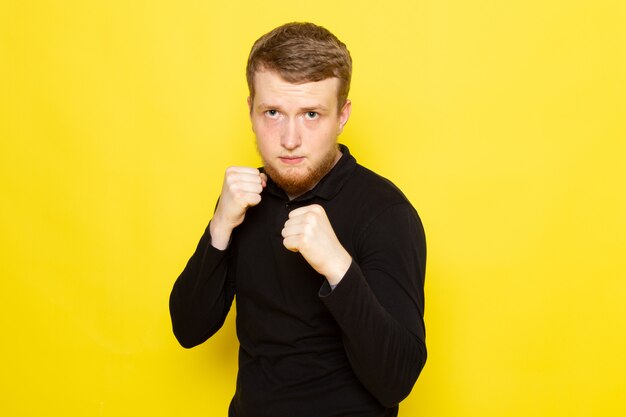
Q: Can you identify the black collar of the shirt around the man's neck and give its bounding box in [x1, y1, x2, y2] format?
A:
[261, 144, 356, 202]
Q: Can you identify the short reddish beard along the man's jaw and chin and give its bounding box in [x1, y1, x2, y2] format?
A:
[257, 145, 338, 198]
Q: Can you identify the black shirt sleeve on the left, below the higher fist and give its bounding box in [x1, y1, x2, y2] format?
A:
[170, 221, 235, 348]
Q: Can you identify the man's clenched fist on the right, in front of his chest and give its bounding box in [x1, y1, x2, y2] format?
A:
[281, 204, 352, 285]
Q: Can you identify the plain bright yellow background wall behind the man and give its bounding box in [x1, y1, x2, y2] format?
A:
[0, 0, 626, 417]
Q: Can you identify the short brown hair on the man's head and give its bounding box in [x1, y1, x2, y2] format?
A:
[246, 22, 352, 111]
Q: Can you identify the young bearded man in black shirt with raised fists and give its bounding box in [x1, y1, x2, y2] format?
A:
[170, 23, 426, 417]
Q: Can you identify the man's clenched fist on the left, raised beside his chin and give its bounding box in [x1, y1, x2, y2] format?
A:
[209, 167, 267, 250]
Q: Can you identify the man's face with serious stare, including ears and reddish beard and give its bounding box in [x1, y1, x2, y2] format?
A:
[248, 71, 351, 197]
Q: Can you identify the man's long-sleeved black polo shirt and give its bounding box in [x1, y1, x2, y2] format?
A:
[170, 146, 426, 417]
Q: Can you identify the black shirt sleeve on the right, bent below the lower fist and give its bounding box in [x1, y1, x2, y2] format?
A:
[319, 204, 426, 407]
